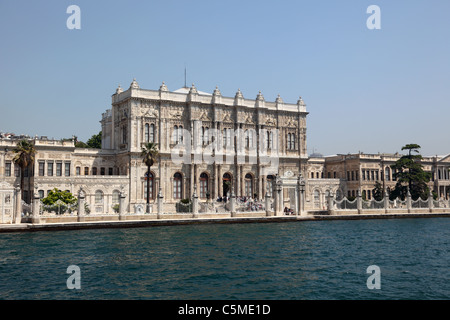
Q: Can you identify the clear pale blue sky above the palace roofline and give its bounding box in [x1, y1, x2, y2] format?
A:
[0, 0, 450, 155]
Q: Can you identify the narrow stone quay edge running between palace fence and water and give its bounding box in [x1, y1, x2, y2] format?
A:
[0, 210, 450, 233]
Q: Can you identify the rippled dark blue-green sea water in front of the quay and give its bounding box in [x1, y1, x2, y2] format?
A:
[0, 218, 450, 300]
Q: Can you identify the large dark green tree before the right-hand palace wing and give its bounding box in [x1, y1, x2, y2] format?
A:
[391, 144, 431, 199]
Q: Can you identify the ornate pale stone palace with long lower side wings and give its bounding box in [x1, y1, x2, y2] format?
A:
[0, 80, 450, 214]
